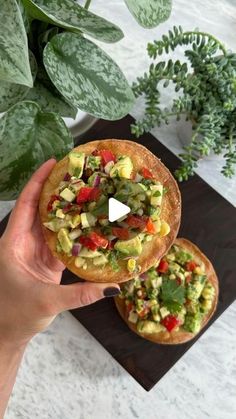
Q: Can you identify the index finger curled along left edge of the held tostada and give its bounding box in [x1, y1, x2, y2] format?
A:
[6, 159, 56, 234]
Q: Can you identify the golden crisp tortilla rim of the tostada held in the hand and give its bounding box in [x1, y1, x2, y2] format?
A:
[39, 139, 181, 283]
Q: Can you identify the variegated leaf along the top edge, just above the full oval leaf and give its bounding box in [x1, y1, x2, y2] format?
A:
[22, 0, 124, 42]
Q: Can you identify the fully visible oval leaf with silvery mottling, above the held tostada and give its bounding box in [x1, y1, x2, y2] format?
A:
[43, 32, 134, 120]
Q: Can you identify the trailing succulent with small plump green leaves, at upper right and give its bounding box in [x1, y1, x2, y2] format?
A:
[131, 27, 236, 181]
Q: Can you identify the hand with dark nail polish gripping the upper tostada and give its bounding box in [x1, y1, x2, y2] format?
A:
[0, 159, 119, 346]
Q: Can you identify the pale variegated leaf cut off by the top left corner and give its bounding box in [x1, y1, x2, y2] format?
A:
[0, 0, 33, 87]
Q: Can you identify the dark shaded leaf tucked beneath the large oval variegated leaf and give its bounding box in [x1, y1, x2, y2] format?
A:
[25, 79, 77, 118]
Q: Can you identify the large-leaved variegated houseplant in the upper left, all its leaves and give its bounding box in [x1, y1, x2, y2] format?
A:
[0, 0, 170, 199]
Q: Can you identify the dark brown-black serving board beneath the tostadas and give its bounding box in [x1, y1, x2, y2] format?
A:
[0, 116, 236, 391]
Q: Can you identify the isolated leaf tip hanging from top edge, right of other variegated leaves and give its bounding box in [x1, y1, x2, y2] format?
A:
[125, 0, 172, 28]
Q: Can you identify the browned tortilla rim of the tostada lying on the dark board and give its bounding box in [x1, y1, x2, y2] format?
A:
[115, 238, 219, 345]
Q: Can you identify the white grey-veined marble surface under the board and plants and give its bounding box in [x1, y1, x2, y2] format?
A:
[0, 0, 236, 419]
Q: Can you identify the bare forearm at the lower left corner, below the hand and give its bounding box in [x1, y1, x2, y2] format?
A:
[0, 337, 25, 419]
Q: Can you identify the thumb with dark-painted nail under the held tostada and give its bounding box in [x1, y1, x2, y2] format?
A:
[43, 282, 120, 314]
